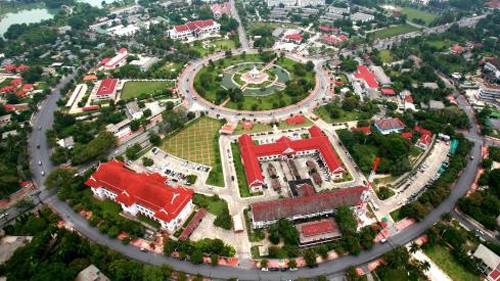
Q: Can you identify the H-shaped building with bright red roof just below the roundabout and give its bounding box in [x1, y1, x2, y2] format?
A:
[238, 126, 344, 188]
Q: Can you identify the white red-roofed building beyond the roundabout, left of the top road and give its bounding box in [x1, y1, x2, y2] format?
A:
[168, 19, 220, 40]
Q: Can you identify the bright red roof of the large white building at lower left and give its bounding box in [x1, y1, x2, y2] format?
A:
[85, 160, 194, 222]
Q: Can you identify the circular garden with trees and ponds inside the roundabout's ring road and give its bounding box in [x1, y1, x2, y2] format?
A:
[194, 52, 315, 111]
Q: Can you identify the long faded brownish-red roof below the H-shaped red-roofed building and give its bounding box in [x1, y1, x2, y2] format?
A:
[251, 187, 366, 222]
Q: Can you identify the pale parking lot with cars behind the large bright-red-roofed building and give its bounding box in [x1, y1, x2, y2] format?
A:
[130, 147, 211, 187]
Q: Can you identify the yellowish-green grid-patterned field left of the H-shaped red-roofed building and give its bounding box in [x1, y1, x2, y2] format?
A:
[163, 117, 221, 167]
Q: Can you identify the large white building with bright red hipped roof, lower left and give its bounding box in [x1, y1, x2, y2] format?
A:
[85, 160, 194, 232]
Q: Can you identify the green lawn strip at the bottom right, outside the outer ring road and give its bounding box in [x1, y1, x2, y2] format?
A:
[424, 245, 481, 281]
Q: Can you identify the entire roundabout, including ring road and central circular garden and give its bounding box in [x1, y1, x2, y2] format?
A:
[182, 49, 329, 118]
